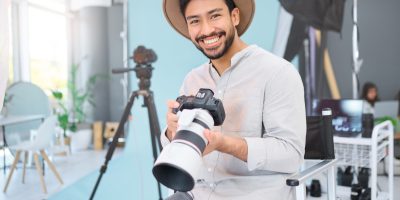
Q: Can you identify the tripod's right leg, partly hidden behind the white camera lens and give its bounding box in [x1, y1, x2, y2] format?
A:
[144, 91, 162, 200]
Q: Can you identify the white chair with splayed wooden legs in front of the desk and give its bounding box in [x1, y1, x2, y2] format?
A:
[3, 116, 63, 193]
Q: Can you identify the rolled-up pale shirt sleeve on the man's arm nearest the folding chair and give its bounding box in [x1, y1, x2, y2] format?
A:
[245, 66, 306, 173]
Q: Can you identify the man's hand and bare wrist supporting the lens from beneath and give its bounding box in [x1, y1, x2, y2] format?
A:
[203, 129, 248, 162]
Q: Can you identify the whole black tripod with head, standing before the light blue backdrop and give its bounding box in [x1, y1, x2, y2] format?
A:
[90, 46, 162, 200]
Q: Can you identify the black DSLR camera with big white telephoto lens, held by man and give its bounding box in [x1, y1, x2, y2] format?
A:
[153, 88, 225, 192]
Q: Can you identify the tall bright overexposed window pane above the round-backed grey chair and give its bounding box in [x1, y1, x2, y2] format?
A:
[28, 0, 68, 92]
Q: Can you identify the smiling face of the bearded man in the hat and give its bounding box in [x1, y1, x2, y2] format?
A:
[185, 0, 239, 59]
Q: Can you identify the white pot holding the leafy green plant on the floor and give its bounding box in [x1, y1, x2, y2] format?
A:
[70, 129, 93, 152]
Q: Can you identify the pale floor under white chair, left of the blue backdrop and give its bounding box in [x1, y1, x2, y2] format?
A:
[0, 149, 121, 200]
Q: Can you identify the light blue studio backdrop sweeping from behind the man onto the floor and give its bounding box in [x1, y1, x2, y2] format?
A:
[52, 0, 279, 199]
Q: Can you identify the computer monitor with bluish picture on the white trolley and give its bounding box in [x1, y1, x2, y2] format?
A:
[312, 99, 363, 137]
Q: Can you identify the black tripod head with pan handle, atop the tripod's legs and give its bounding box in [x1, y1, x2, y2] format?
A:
[112, 46, 157, 91]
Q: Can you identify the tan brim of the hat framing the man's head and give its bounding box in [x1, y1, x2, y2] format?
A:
[163, 0, 256, 39]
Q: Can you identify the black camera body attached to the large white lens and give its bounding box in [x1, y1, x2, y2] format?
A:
[173, 88, 225, 126]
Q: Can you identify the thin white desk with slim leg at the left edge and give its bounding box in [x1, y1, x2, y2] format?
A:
[0, 115, 45, 174]
